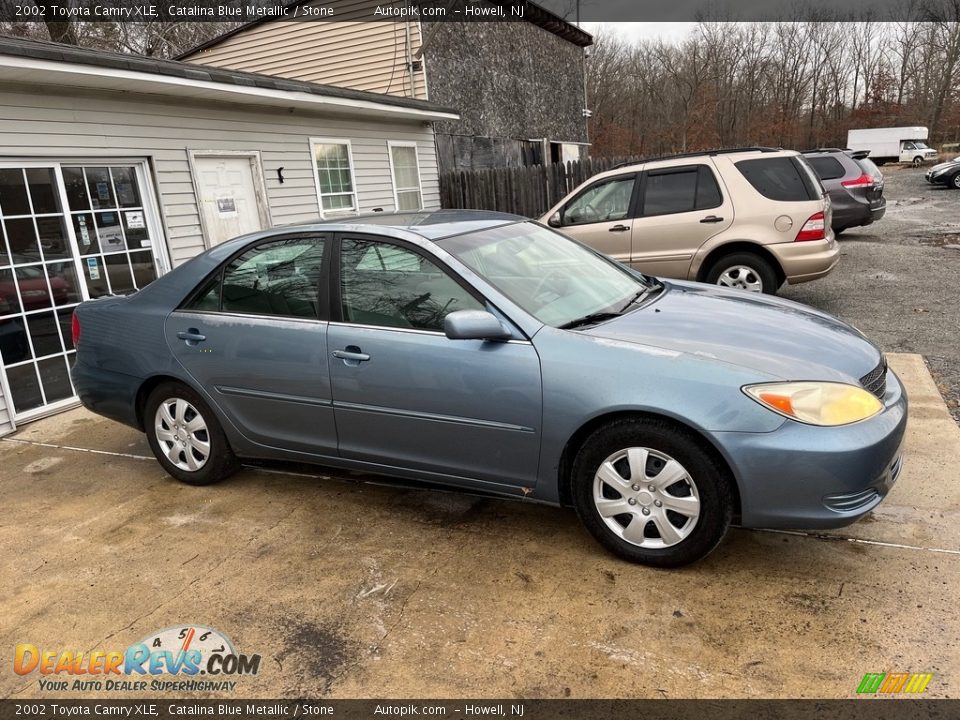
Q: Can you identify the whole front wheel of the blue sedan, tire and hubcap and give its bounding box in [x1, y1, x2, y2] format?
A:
[572, 419, 733, 567]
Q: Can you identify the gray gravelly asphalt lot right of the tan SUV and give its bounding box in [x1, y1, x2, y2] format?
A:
[780, 166, 960, 423]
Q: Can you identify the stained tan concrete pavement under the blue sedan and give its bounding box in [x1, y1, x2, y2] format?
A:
[0, 355, 960, 698]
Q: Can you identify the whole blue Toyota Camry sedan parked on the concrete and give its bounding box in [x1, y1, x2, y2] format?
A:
[73, 211, 907, 566]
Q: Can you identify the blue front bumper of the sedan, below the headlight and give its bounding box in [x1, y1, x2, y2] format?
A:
[716, 370, 907, 530]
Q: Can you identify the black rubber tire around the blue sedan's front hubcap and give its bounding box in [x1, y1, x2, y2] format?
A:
[571, 418, 734, 568]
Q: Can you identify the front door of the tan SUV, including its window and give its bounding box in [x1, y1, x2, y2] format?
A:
[557, 173, 637, 263]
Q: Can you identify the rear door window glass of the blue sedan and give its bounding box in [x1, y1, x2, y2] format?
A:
[189, 238, 326, 318]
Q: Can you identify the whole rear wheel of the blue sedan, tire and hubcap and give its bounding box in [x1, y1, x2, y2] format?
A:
[143, 382, 238, 485]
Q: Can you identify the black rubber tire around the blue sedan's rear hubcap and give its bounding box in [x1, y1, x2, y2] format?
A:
[143, 382, 239, 485]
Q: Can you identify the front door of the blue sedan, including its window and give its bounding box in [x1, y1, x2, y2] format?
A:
[328, 234, 542, 486]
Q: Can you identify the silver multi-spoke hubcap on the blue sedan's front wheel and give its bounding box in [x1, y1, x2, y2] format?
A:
[593, 447, 700, 549]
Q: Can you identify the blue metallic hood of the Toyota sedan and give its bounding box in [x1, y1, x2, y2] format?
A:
[584, 281, 882, 382]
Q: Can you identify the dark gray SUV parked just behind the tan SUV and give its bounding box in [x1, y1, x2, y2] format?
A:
[803, 148, 887, 235]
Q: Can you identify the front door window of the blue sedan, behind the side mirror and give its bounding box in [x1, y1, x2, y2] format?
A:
[340, 239, 483, 331]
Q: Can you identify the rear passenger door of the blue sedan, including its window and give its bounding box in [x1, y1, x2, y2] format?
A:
[165, 235, 337, 455]
